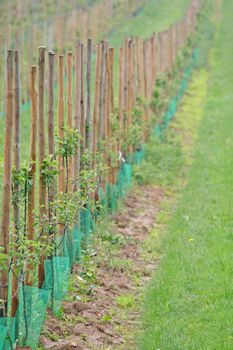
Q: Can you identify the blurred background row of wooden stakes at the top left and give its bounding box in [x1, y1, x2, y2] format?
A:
[0, 0, 145, 111]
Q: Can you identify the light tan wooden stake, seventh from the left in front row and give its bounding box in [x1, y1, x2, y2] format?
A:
[67, 52, 73, 192]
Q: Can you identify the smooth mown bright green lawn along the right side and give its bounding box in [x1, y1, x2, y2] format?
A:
[139, 0, 233, 350]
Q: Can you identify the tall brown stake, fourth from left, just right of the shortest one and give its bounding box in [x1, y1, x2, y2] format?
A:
[38, 47, 46, 288]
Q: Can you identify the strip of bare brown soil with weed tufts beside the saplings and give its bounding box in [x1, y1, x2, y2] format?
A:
[41, 186, 164, 350]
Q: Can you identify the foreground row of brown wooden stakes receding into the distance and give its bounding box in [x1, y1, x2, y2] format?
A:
[0, 0, 200, 316]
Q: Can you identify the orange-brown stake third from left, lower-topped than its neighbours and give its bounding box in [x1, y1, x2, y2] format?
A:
[26, 66, 38, 285]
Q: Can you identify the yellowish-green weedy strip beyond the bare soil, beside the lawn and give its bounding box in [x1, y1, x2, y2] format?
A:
[133, 69, 207, 191]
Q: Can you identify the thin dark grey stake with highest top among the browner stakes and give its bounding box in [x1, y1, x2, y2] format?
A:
[85, 39, 92, 150]
